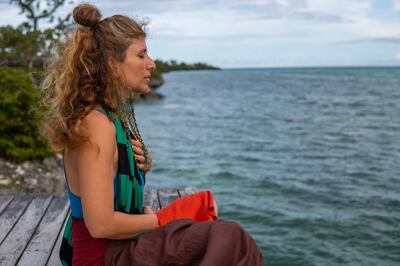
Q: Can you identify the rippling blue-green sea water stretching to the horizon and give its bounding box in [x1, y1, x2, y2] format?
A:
[136, 68, 400, 265]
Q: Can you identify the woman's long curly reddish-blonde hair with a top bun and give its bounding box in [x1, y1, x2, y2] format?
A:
[40, 4, 146, 153]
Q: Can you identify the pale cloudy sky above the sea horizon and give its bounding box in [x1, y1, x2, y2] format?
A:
[0, 0, 400, 68]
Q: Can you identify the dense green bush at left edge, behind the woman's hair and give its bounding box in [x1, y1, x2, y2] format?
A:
[0, 67, 53, 162]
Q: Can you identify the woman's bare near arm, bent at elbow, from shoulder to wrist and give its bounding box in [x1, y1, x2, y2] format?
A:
[77, 111, 158, 239]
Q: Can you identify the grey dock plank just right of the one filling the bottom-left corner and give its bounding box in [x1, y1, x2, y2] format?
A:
[18, 196, 69, 266]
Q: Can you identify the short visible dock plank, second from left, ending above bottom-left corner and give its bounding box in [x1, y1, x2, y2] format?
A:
[0, 196, 32, 245]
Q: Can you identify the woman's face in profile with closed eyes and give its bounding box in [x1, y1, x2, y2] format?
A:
[118, 38, 156, 93]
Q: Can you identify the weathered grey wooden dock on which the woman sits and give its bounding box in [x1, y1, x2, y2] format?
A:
[0, 187, 198, 266]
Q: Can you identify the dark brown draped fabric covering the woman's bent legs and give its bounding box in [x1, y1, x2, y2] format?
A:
[104, 219, 264, 266]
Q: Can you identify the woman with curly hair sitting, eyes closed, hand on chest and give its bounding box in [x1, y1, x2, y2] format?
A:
[42, 4, 261, 265]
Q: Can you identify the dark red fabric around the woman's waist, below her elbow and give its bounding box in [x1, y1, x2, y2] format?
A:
[72, 219, 110, 266]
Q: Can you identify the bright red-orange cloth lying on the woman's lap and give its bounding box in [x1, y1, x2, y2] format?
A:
[156, 190, 217, 226]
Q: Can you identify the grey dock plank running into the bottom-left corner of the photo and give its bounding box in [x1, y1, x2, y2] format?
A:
[0, 196, 53, 266]
